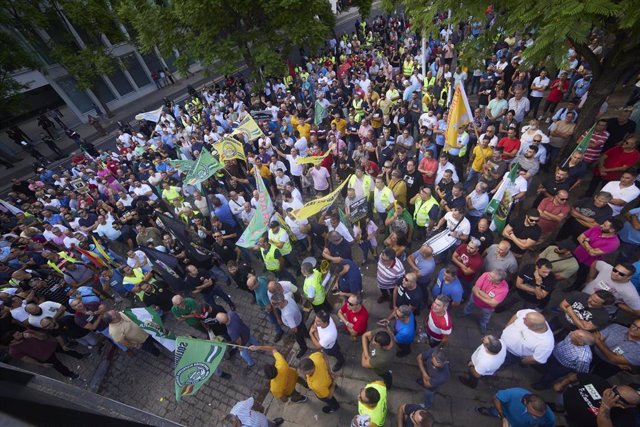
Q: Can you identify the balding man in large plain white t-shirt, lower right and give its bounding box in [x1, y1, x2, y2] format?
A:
[500, 310, 554, 367]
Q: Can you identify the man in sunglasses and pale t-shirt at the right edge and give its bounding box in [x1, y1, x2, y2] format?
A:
[582, 261, 640, 316]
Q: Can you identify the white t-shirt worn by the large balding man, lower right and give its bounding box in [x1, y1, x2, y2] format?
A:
[500, 310, 554, 364]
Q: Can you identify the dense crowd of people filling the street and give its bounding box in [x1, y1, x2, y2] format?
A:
[0, 11, 640, 427]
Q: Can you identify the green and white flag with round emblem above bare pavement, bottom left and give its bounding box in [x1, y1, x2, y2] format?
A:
[174, 337, 227, 402]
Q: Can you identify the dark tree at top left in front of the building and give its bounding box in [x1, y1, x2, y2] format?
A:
[0, 0, 131, 115]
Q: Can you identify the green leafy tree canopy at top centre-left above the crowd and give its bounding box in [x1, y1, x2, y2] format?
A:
[117, 0, 335, 87]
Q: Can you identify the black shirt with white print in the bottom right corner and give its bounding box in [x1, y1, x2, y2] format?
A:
[562, 374, 638, 427]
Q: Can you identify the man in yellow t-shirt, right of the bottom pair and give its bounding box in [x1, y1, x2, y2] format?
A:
[298, 351, 340, 414]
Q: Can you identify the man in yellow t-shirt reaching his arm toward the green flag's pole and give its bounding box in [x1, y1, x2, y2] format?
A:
[249, 345, 307, 403]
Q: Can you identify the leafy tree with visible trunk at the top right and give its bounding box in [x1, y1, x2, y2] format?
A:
[385, 0, 640, 139]
